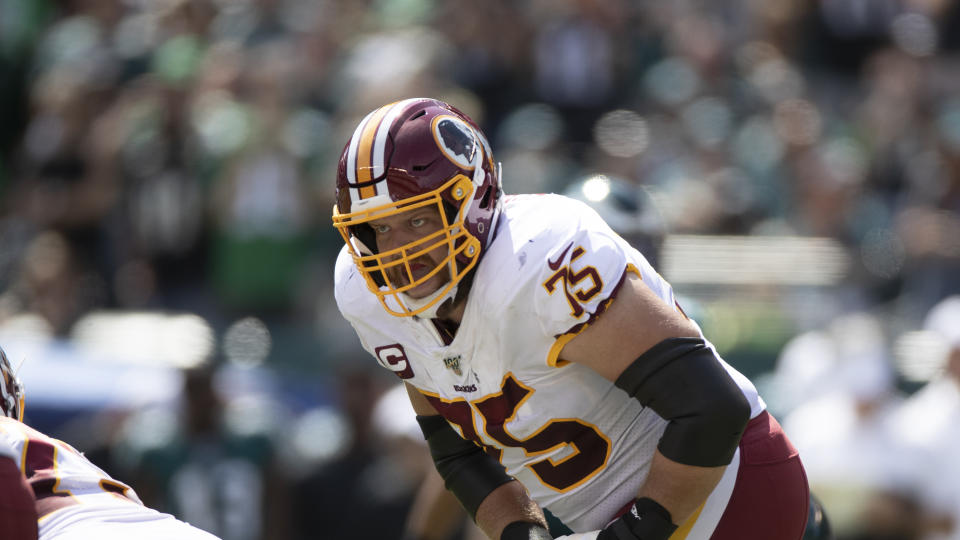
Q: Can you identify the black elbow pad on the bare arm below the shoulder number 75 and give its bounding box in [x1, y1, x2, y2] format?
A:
[614, 337, 750, 467]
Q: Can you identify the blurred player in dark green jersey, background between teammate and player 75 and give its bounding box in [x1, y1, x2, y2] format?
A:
[126, 364, 288, 540]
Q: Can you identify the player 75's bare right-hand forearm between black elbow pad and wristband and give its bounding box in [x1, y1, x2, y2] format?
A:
[637, 450, 726, 525]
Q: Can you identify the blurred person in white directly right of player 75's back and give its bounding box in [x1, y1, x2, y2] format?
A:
[777, 312, 904, 540]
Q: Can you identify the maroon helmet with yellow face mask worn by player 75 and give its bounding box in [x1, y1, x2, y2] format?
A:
[333, 98, 501, 317]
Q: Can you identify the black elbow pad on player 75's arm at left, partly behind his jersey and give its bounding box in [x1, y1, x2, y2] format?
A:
[417, 415, 513, 521]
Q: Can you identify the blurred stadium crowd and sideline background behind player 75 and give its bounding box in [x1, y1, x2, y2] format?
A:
[0, 0, 960, 540]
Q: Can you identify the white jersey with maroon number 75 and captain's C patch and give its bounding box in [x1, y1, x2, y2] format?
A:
[336, 195, 764, 538]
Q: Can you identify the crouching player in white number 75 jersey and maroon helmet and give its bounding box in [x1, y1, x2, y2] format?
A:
[333, 99, 809, 540]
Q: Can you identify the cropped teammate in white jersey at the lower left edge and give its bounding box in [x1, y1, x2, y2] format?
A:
[0, 348, 217, 540]
